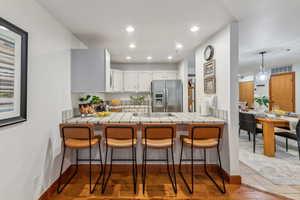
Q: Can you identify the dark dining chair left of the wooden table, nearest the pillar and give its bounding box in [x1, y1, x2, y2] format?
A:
[239, 112, 263, 153]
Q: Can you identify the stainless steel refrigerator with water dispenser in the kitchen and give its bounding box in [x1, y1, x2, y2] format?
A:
[151, 80, 182, 112]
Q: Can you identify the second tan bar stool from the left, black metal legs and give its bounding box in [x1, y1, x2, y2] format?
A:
[102, 124, 137, 193]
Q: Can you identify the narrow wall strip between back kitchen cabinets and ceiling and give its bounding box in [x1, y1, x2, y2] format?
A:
[111, 63, 177, 71]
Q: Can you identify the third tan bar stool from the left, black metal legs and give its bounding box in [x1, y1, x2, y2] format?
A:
[142, 124, 177, 193]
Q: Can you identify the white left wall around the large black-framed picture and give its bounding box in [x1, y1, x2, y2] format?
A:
[0, 0, 84, 200]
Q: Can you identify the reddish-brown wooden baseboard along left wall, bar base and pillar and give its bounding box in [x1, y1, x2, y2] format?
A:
[39, 164, 242, 200]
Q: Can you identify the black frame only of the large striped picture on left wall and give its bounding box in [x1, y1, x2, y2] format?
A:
[0, 17, 28, 127]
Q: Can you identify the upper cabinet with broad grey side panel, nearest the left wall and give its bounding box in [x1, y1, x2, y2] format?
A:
[71, 48, 110, 92]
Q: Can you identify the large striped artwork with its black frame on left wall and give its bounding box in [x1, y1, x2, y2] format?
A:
[0, 17, 28, 126]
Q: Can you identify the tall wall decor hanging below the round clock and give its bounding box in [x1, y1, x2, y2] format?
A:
[203, 60, 216, 94]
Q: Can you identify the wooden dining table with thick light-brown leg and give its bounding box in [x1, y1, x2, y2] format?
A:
[256, 117, 289, 157]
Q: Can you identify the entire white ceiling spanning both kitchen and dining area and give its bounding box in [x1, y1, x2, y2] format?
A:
[37, 0, 300, 70]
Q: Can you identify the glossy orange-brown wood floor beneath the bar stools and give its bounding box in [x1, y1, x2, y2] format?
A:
[50, 168, 286, 200]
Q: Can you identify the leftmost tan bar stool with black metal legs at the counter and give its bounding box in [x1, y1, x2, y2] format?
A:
[57, 124, 103, 193]
